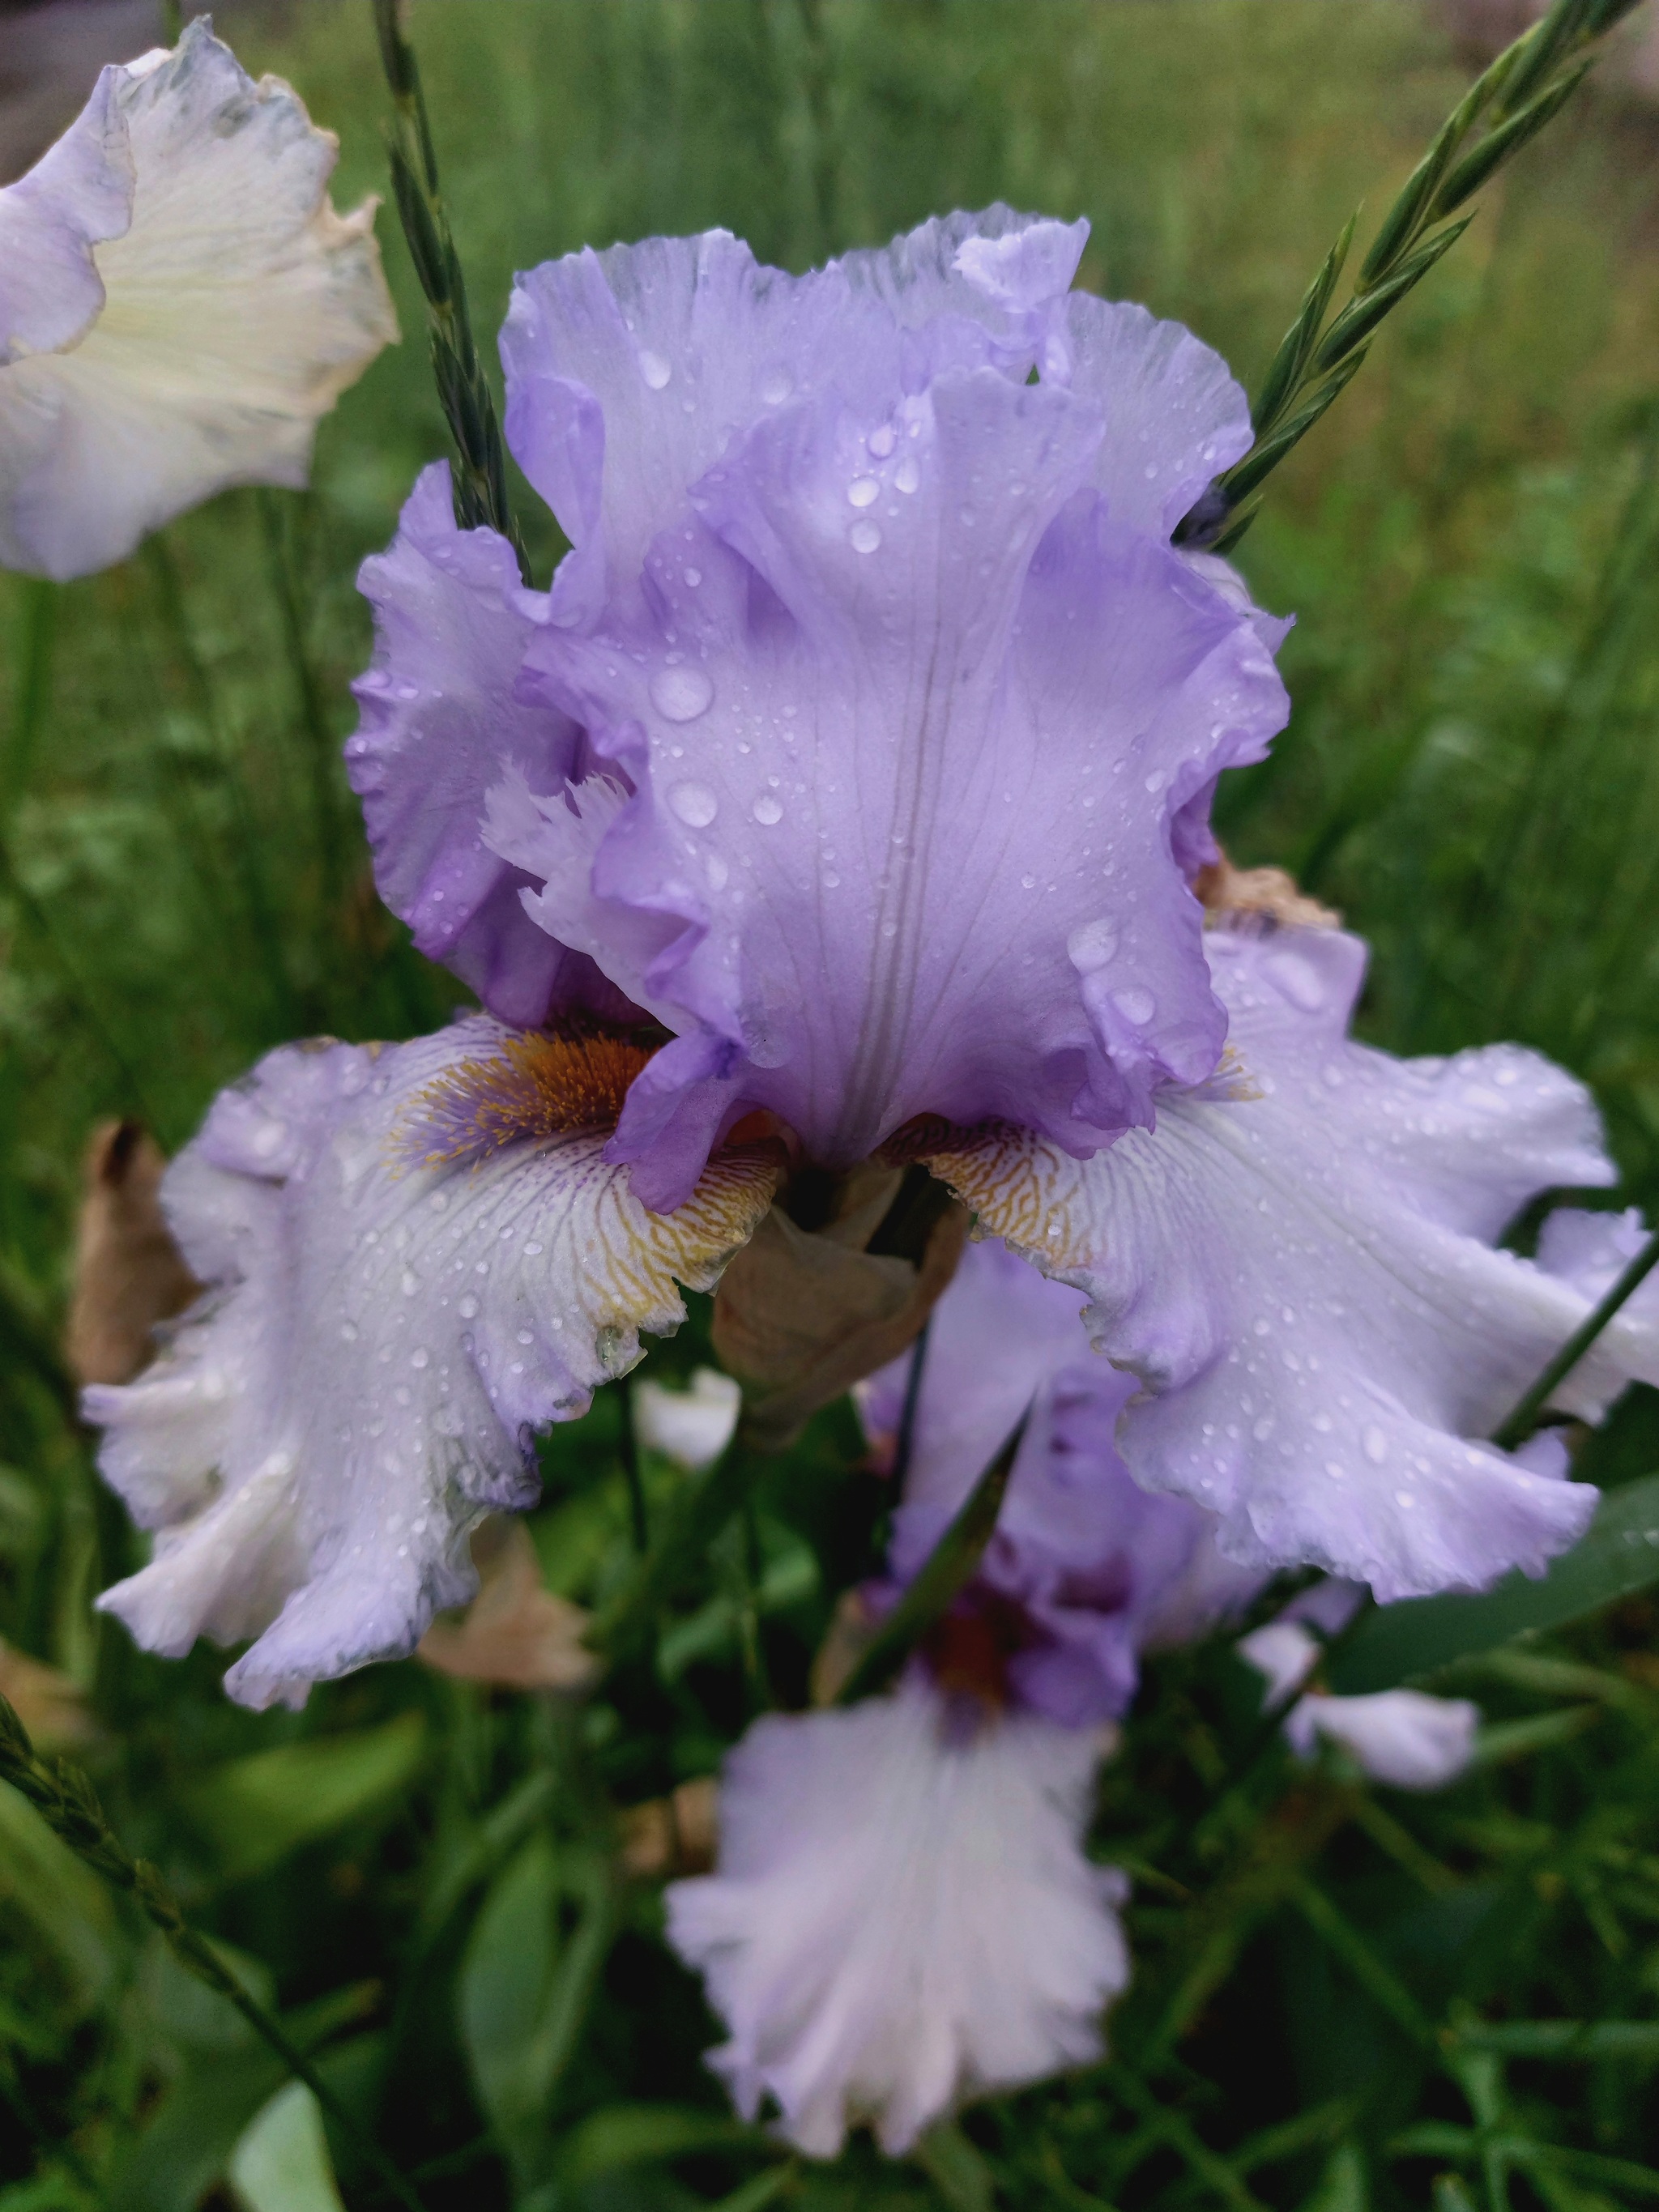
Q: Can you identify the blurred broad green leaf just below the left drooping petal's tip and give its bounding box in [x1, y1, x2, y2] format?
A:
[179, 1712, 424, 1882]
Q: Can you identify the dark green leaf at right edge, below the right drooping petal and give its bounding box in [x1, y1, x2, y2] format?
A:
[1327, 1476, 1659, 1697]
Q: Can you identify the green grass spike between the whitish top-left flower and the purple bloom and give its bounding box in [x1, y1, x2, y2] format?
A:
[373, 0, 531, 584]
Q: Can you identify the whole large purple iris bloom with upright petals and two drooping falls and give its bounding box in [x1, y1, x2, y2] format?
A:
[88, 208, 1659, 1712]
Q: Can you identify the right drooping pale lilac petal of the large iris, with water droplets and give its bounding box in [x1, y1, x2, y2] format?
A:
[933, 929, 1659, 1600]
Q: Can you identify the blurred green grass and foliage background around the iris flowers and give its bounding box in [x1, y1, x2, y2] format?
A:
[0, 0, 1659, 2212]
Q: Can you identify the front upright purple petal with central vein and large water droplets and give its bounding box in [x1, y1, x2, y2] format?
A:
[506, 369, 1283, 1201]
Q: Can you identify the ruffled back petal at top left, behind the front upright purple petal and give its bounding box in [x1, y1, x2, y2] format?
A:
[502, 208, 1086, 626]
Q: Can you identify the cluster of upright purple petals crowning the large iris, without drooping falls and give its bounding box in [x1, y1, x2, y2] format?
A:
[348, 208, 1286, 1208]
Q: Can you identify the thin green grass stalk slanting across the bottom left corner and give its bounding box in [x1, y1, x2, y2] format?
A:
[0, 1697, 424, 2212]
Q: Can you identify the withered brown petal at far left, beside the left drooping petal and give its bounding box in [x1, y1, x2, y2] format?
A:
[64, 1122, 201, 1383]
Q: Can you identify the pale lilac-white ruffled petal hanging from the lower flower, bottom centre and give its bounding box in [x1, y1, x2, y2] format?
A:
[668, 1679, 1128, 2159]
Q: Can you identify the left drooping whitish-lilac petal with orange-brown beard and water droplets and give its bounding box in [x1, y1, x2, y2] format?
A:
[86, 1016, 776, 1706]
